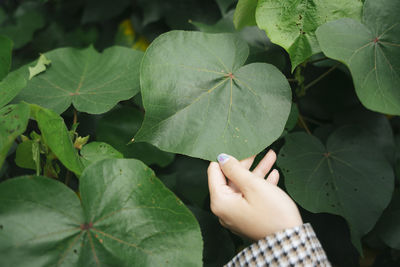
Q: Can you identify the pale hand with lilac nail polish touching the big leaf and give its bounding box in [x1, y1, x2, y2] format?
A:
[207, 150, 303, 240]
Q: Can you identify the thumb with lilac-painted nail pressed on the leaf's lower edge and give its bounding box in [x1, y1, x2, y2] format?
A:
[217, 153, 256, 194]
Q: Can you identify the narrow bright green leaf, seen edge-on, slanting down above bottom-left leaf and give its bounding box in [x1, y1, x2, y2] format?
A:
[31, 105, 83, 176]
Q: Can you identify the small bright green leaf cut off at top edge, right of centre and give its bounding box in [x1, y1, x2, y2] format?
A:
[233, 0, 257, 30]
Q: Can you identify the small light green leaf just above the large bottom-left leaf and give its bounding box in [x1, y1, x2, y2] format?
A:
[81, 142, 124, 167]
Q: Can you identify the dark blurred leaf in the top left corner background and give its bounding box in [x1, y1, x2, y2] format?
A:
[0, 8, 45, 49]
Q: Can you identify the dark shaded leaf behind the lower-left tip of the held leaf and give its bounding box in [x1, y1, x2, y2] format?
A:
[96, 107, 174, 167]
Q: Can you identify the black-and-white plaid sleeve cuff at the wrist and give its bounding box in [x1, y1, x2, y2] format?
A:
[225, 223, 331, 267]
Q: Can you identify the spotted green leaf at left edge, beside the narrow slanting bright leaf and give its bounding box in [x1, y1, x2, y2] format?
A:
[0, 103, 30, 168]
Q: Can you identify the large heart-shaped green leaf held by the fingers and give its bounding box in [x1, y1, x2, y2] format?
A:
[135, 31, 291, 160]
